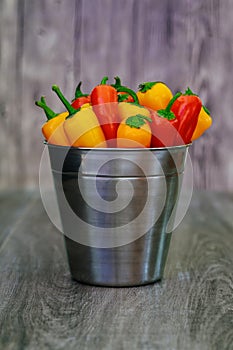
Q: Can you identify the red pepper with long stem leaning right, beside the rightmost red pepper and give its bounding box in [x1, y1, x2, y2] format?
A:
[150, 92, 181, 147]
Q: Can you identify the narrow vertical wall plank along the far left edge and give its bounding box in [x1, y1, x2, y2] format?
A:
[0, 0, 20, 188]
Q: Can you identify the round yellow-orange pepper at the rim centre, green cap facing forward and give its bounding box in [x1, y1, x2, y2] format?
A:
[117, 114, 151, 148]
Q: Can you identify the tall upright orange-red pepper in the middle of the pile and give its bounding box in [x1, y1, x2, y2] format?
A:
[91, 77, 119, 140]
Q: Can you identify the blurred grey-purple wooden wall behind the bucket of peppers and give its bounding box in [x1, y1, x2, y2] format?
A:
[0, 0, 233, 191]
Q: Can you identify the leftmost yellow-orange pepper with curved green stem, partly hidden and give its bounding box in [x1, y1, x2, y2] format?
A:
[35, 96, 70, 146]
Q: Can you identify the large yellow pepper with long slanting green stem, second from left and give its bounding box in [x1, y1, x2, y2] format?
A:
[52, 85, 107, 148]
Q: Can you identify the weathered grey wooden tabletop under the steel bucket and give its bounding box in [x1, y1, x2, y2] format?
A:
[0, 191, 233, 350]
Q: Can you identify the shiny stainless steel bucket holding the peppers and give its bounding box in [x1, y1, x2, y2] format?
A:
[48, 145, 188, 286]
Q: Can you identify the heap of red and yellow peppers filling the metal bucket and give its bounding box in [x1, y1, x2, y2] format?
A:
[35, 77, 212, 148]
